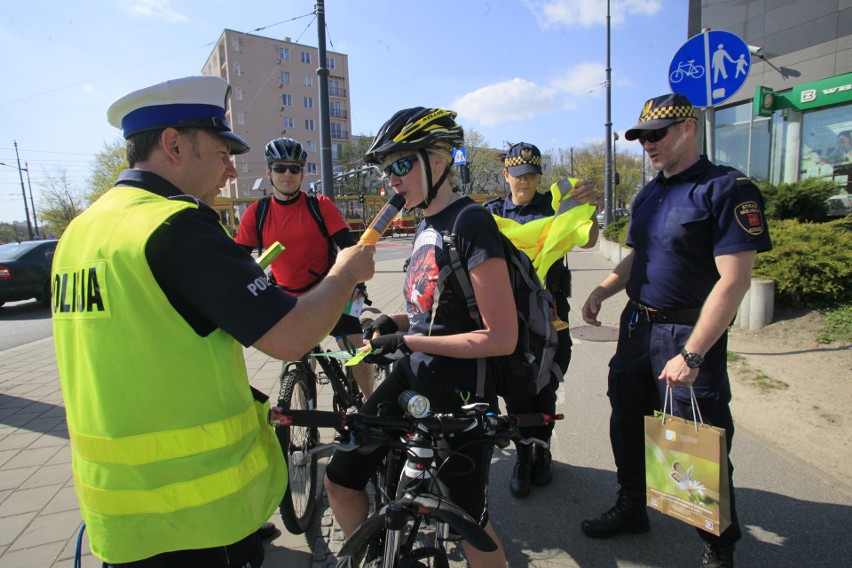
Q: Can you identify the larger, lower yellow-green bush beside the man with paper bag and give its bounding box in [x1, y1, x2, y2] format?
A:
[754, 217, 852, 306]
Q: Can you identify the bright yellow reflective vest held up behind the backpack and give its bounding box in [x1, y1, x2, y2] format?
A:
[494, 178, 595, 282]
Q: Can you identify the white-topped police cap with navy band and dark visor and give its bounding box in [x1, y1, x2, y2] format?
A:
[107, 75, 249, 154]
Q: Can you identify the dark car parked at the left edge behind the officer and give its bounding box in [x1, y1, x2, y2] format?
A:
[0, 240, 59, 306]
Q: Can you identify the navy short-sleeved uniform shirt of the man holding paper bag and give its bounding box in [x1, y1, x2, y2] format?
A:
[627, 156, 772, 310]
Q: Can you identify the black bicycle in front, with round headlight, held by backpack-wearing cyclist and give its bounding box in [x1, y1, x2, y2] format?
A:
[270, 391, 562, 568]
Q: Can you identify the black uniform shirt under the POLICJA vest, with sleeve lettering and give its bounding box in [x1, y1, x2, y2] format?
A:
[115, 170, 296, 346]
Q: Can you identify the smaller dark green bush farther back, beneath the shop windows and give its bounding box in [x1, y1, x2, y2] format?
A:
[760, 178, 836, 222]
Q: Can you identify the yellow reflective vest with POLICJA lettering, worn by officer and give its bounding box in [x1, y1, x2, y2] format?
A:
[52, 187, 287, 563]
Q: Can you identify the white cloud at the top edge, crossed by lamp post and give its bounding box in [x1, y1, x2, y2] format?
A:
[524, 0, 662, 30]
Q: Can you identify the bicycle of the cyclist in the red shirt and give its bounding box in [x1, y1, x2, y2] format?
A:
[276, 308, 389, 534]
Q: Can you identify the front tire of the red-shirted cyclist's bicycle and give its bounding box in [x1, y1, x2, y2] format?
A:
[275, 368, 319, 534]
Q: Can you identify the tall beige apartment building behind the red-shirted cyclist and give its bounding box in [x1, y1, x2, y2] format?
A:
[202, 29, 351, 202]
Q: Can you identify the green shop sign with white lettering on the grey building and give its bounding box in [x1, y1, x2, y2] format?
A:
[754, 73, 852, 116]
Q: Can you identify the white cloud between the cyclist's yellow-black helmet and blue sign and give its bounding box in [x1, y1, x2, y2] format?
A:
[452, 77, 559, 126]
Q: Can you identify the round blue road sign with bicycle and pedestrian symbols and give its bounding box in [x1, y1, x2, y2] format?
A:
[669, 30, 751, 107]
